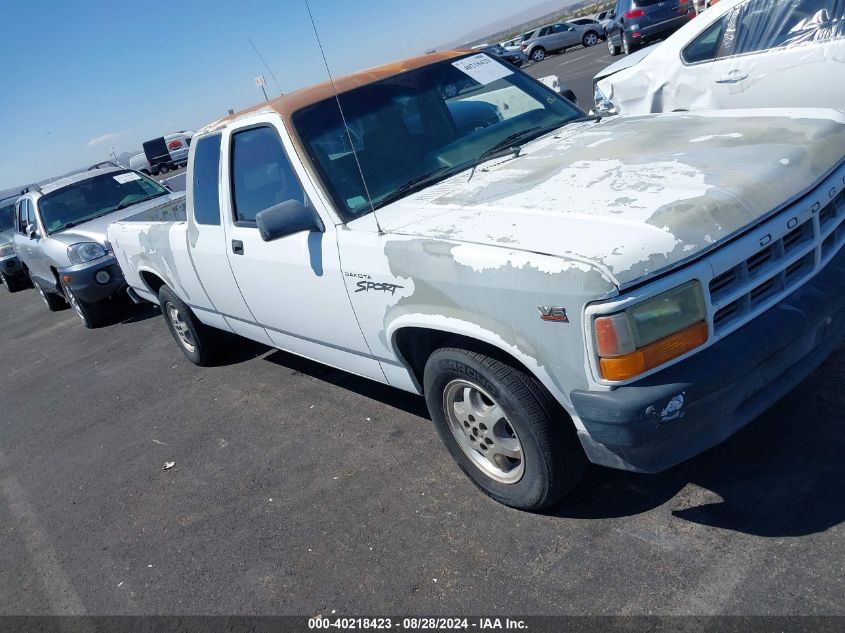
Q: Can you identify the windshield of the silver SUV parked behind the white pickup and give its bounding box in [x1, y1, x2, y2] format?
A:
[38, 171, 168, 235]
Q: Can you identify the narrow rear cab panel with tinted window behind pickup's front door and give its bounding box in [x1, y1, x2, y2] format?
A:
[186, 133, 272, 345]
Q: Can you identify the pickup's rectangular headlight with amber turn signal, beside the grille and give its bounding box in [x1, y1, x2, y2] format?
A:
[593, 281, 709, 381]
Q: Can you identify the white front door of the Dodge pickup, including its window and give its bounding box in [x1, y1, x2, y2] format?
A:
[222, 116, 385, 381]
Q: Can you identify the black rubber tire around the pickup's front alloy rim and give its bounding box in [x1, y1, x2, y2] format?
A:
[423, 348, 586, 511]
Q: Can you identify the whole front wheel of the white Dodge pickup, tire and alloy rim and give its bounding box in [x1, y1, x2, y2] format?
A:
[423, 348, 586, 510]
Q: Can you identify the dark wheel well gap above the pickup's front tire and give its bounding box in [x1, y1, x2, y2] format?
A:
[394, 327, 539, 392]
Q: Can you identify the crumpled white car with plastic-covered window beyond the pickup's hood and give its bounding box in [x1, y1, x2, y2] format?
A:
[593, 0, 845, 114]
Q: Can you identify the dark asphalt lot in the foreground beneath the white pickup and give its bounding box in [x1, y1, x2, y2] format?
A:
[0, 276, 845, 615]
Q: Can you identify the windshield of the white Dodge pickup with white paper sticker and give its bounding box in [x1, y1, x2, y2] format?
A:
[293, 53, 584, 220]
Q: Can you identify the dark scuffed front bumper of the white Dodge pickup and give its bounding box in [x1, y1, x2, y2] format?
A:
[571, 244, 845, 472]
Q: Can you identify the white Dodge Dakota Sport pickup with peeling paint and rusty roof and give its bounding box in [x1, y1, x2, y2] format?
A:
[108, 53, 845, 509]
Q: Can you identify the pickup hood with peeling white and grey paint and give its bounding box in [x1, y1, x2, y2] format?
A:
[378, 109, 845, 289]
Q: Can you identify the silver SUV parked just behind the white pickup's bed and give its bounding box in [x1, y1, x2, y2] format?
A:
[13, 166, 184, 328]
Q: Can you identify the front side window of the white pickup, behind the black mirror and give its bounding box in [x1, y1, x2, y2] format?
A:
[231, 125, 306, 224]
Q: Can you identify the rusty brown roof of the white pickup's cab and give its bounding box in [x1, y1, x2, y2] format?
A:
[197, 50, 478, 134]
